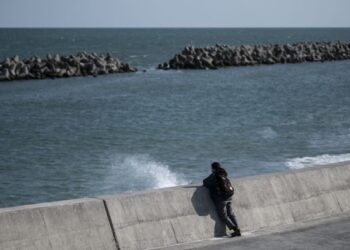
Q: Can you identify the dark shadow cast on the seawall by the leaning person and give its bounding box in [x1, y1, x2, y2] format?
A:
[191, 186, 226, 237]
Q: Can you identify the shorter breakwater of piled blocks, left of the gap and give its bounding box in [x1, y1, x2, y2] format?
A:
[0, 52, 137, 81]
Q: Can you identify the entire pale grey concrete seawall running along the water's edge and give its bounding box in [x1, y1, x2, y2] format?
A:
[0, 162, 350, 249]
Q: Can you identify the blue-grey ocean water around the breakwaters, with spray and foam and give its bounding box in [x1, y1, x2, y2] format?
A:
[0, 29, 350, 207]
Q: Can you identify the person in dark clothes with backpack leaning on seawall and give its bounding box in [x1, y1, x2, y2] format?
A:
[203, 162, 241, 237]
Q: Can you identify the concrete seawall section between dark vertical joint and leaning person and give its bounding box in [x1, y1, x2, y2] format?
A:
[103, 187, 225, 249]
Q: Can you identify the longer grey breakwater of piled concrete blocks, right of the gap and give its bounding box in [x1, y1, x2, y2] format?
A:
[158, 42, 350, 70]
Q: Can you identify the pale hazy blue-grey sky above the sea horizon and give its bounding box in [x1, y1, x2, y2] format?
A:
[0, 0, 350, 27]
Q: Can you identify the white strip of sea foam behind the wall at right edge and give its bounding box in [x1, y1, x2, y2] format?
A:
[285, 153, 350, 169]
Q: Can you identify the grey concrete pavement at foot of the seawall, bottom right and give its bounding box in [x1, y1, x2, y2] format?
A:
[162, 213, 350, 250]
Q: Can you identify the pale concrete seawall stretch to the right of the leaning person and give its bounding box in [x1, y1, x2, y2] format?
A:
[232, 162, 350, 231]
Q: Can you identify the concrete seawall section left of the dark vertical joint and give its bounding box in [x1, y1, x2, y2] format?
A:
[0, 199, 116, 250]
